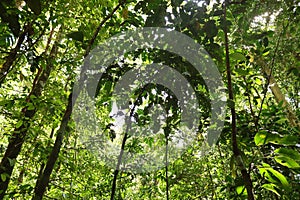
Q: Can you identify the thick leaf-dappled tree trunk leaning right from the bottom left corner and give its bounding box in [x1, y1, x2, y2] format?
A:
[0, 28, 57, 199]
